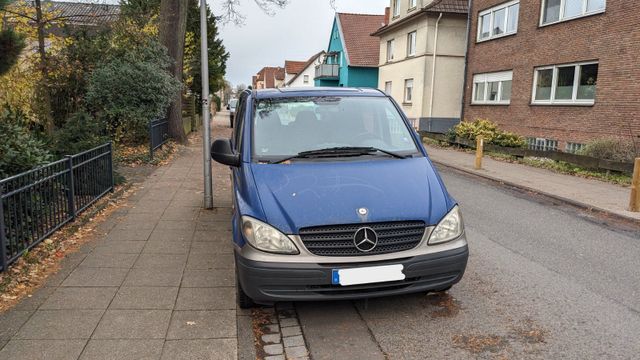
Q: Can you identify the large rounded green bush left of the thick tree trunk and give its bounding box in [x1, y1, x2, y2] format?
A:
[86, 39, 181, 144]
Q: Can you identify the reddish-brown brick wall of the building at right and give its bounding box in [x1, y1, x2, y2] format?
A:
[464, 0, 640, 150]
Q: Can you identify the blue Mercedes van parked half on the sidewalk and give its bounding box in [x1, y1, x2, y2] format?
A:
[211, 88, 469, 308]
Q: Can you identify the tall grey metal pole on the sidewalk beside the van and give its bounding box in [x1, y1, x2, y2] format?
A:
[200, 0, 213, 209]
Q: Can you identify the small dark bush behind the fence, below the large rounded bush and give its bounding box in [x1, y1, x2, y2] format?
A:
[53, 111, 109, 156]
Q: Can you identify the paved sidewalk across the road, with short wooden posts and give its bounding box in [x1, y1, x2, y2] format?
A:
[426, 146, 640, 222]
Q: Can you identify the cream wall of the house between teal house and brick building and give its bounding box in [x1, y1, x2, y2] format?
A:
[378, 11, 466, 119]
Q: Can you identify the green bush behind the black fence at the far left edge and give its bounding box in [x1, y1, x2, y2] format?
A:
[0, 109, 52, 179]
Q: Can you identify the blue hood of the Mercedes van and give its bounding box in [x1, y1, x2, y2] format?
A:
[252, 157, 454, 234]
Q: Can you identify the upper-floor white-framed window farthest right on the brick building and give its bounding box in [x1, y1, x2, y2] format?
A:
[540, 0, 607, 25]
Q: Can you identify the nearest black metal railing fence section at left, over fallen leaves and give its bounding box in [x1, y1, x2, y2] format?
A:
[0, 142, 113, 271]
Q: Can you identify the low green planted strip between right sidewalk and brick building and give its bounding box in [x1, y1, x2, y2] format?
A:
[420, 131, 633, 174]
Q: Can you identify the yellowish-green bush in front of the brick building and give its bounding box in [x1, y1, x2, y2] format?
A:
[454, 119, 527, 147]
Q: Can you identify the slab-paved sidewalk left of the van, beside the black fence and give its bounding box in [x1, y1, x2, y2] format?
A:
[0, 114, 238, 360]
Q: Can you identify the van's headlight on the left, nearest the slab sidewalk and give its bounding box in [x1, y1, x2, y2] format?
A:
[242, 216, 300, 254]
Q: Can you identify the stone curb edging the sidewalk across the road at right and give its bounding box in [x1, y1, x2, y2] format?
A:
[430, 158, 640, 225]
